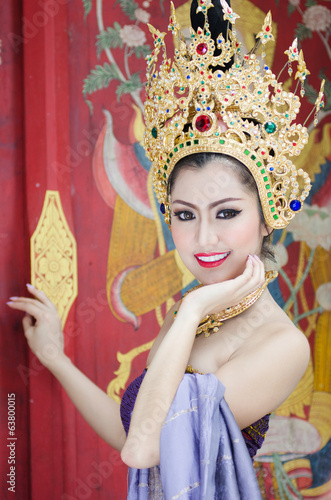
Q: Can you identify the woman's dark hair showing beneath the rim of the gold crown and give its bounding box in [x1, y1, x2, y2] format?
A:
[167, 153, 275, 262]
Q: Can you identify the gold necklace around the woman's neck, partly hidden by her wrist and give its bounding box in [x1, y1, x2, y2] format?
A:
[174, 271, 278, 337]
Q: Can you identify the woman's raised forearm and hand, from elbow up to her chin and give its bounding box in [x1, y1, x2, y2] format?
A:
[121, 254, 264, 468]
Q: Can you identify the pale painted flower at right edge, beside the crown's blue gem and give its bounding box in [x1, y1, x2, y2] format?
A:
[288, 205, 331, 250]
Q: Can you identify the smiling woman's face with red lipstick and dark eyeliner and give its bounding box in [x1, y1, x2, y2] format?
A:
[171, 160, 268, 284]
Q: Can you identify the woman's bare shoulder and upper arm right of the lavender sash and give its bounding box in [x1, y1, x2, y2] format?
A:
[215, 315, 310, 428]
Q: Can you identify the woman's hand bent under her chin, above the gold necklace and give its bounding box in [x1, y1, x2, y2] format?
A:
[180, 255, 265, 319]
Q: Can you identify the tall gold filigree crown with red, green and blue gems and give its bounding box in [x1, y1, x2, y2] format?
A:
[144, 0, 323, 229]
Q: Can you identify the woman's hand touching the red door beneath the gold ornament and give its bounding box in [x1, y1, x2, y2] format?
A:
[7, 285, 64, 368]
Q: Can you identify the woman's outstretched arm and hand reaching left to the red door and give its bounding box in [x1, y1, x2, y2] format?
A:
[8, 286, 126, 451]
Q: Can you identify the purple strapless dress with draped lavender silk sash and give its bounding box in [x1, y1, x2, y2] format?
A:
[121, 370, 269, 500]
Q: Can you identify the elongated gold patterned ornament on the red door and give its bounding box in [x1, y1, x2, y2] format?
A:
[31, 191, 78, 327]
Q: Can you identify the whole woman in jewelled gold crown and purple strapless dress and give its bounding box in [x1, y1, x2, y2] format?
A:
[8, 0, 320, 500]
